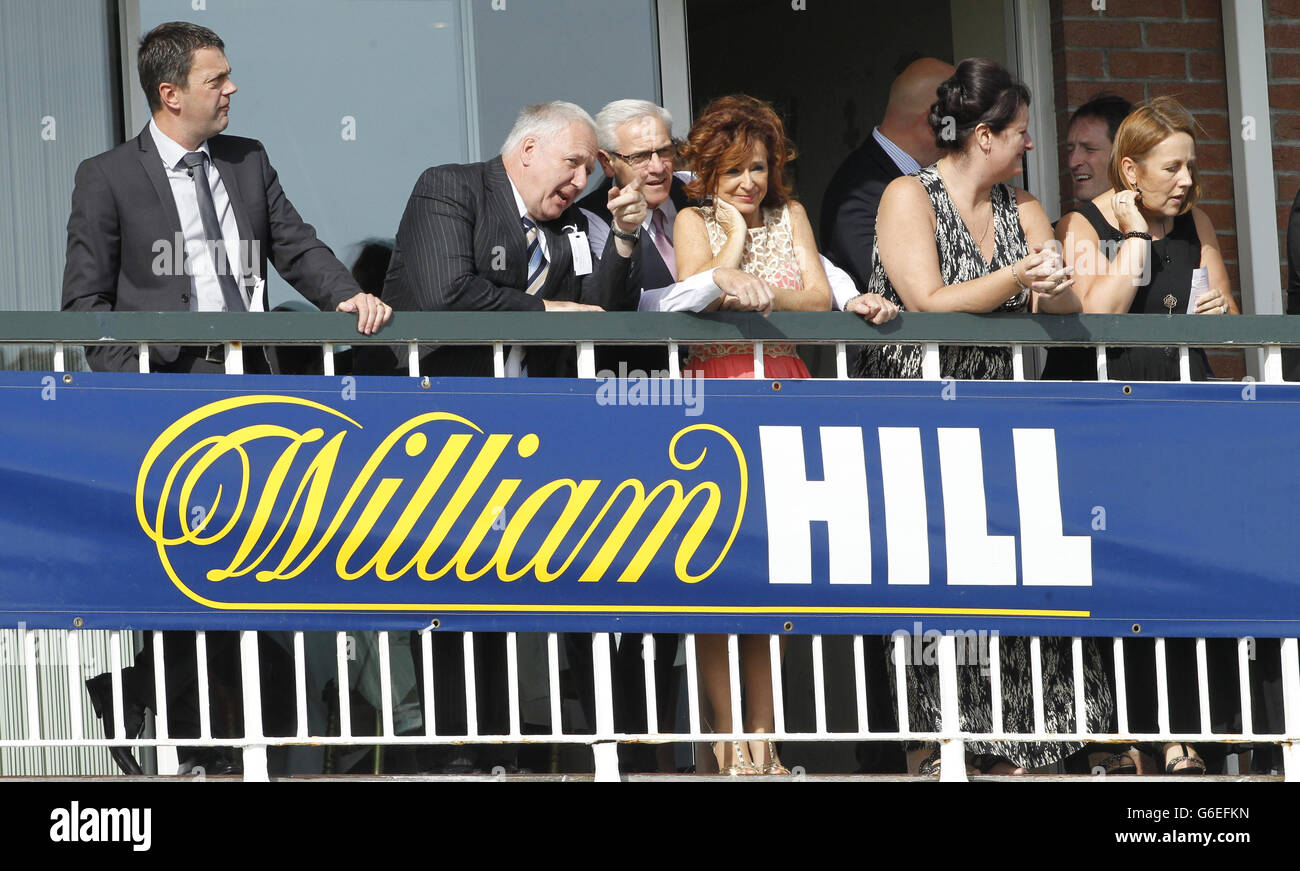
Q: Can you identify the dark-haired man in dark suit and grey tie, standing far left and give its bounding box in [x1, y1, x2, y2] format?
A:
[62, 22, 391, 774]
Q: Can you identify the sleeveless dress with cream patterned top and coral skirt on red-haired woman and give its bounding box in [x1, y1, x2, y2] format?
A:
[685, 205, 811, 378]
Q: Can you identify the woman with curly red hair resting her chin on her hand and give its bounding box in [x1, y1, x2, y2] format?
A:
[673, 95, 897, 775]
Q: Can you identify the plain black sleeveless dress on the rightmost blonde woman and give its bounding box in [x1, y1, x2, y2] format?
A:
[1043, 202, 1212, 381]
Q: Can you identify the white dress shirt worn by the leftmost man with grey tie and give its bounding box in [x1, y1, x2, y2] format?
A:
[150, 121, 264, 312]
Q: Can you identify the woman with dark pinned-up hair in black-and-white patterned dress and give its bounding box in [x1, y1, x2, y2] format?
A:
[854, 59, 1113, 774]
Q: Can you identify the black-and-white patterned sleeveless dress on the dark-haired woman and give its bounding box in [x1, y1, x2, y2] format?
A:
[854, 166, 1114, 768]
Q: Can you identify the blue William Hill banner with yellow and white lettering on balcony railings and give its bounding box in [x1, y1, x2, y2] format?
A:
[0, 373, 1300, 636]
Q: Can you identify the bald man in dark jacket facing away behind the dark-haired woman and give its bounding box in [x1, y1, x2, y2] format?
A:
[822, 57, 954, 290]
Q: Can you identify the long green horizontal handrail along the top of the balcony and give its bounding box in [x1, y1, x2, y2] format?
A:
[0, 312, 1300, 347]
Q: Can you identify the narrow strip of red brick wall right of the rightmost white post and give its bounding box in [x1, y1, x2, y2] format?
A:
[1264, 0, 1300, 300]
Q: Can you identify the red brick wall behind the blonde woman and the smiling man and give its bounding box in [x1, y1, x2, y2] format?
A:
[1052, 0, 1237, 377]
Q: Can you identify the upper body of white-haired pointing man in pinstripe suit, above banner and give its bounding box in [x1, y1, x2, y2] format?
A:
[384, 101, 646, 376]
